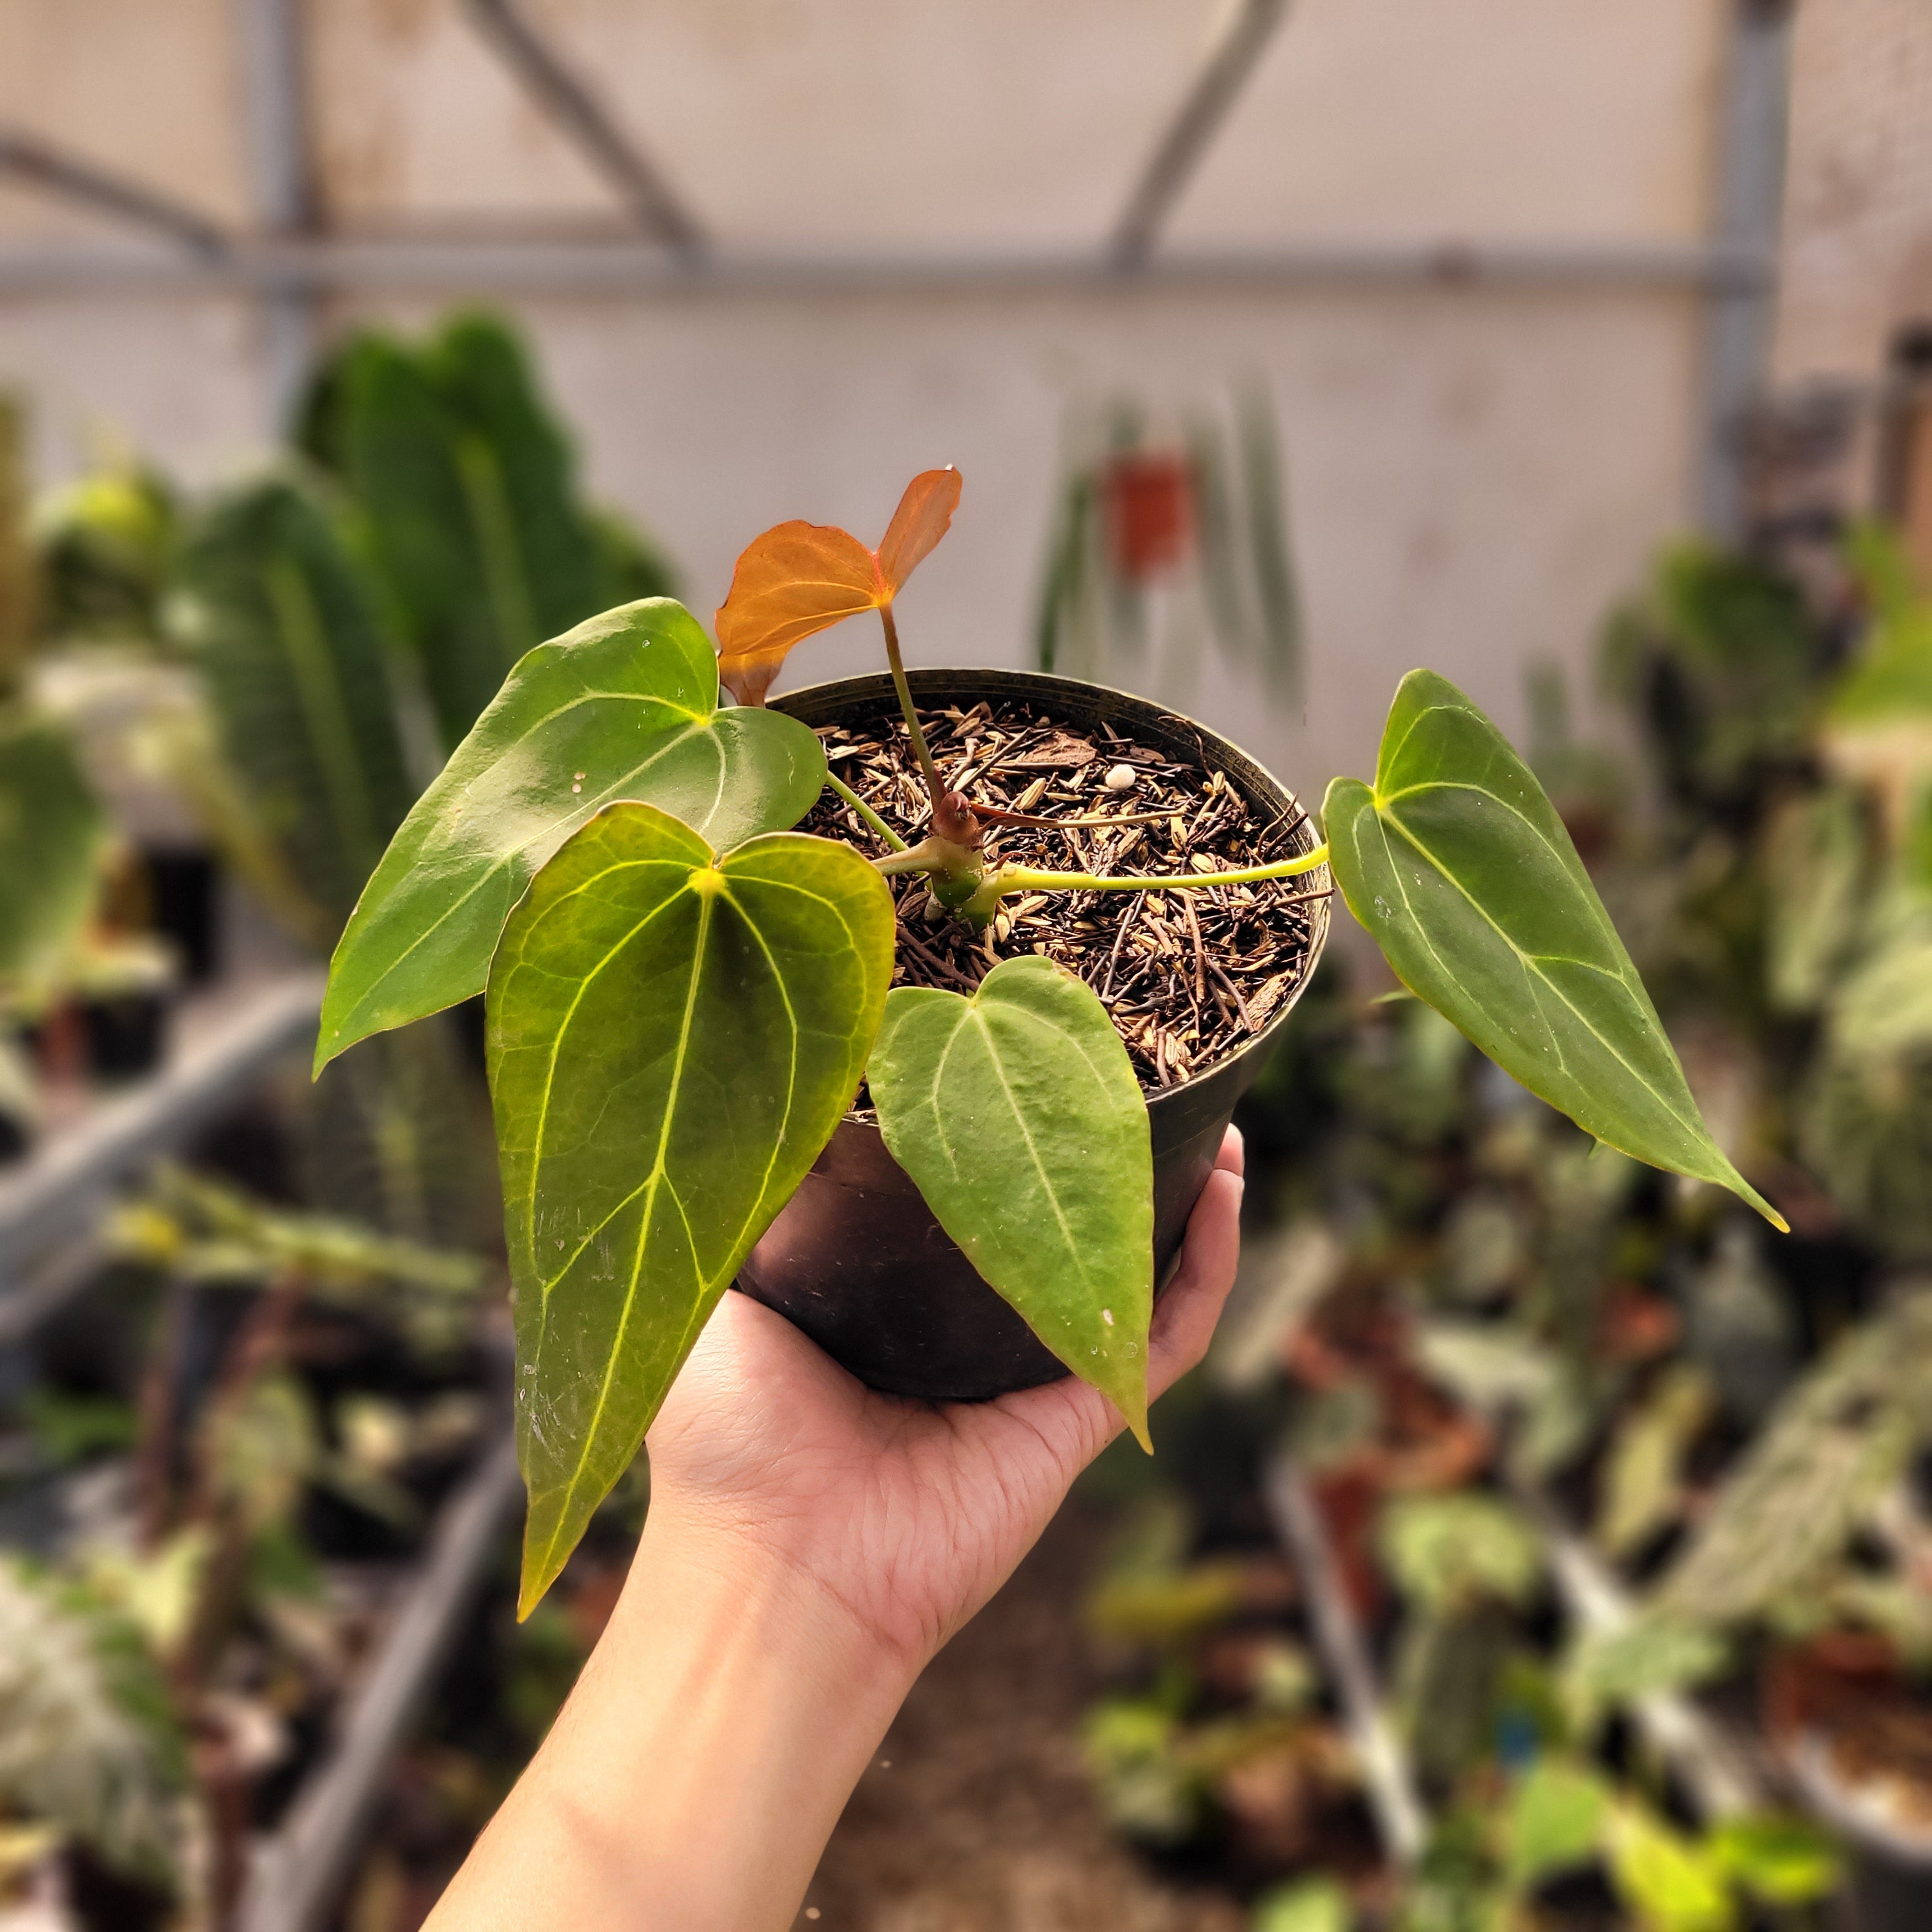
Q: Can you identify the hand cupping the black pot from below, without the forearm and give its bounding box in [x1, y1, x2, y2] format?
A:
[647, 1128, 1242, 1681]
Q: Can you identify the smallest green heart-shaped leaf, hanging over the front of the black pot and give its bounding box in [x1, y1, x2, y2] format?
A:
[866, 954, 1153, 1447]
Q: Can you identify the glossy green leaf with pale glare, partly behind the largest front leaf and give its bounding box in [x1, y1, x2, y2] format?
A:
[315, 597, 825, 1072]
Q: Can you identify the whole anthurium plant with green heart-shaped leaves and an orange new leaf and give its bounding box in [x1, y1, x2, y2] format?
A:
[317, 470, 1783, 1611]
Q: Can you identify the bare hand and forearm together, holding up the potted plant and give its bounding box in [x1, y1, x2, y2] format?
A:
[425, 1130, 1240, 1932]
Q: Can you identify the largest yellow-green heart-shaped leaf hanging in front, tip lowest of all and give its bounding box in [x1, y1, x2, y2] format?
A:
[489, 804, 893, 1613]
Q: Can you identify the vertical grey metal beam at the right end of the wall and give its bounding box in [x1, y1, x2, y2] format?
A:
[1698, 0, 1793, 541]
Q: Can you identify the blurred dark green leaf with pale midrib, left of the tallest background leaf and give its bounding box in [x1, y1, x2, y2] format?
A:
[168, 477, 415, 937]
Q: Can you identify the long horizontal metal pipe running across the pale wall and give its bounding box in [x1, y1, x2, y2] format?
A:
[0, 238, 1774, 298]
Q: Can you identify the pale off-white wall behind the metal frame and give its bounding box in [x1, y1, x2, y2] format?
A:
[0, 0, 1725, 788]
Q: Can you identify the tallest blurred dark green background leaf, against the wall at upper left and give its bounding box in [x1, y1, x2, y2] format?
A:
[302, 315, 672, 747]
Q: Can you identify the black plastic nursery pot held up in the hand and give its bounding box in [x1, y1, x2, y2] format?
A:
[736, 670, 1327, 1400]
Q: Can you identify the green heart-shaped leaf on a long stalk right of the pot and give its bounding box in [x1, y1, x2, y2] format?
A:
[1321, 670, 1785, 1227]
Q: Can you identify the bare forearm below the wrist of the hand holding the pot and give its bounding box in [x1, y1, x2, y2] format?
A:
[429, 1513, 912, 1932]
